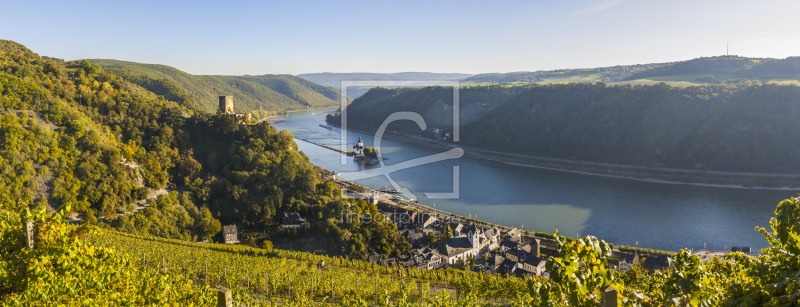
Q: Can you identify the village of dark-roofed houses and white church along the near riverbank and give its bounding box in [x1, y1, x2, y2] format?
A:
[220, 168, 676, 278]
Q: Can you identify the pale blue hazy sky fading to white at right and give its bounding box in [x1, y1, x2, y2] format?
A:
[0, 0, 800, 75]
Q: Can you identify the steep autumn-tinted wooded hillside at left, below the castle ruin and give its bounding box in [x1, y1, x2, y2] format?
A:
[0, 40, 409, 260]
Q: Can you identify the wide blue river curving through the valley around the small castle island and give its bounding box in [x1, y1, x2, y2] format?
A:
[275, 110, 797, 251]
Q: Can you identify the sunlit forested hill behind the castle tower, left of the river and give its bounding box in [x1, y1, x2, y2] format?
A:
[89, 59, 340, 112]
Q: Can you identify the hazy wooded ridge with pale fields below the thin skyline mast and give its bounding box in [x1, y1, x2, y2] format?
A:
[625, 56, 800, 83]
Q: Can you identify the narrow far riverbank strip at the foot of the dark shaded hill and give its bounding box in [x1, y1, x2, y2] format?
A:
[330, 126, 800, 191]
